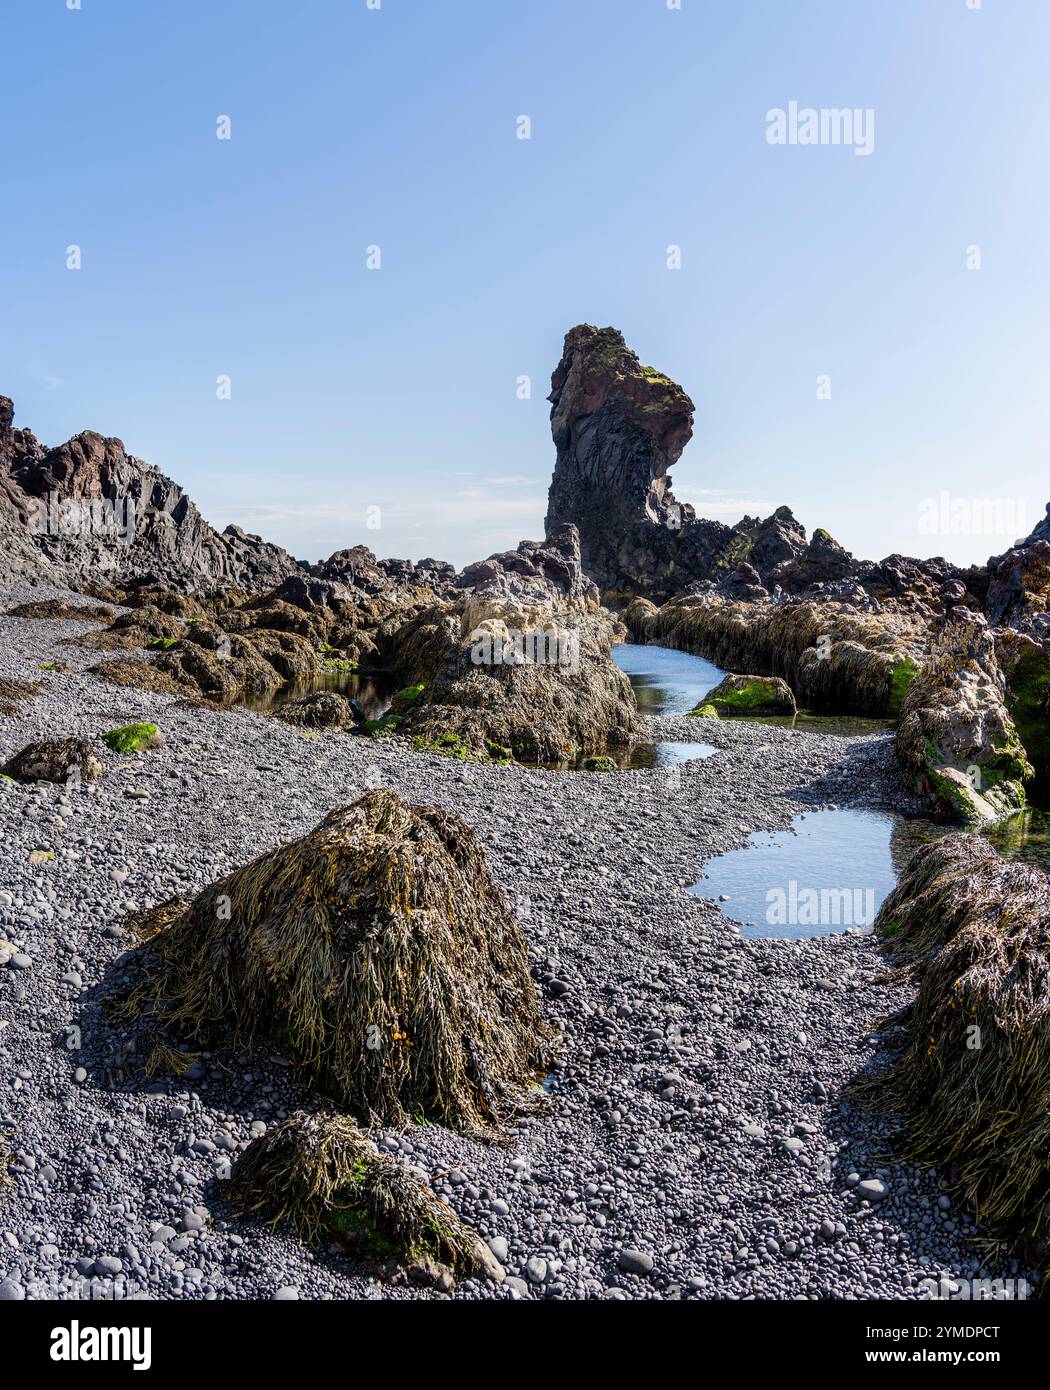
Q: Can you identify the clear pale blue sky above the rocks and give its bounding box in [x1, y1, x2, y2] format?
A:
[0, 0, 1050, 564]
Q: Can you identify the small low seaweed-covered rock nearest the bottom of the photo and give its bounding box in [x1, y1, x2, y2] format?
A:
[225, 1111, 503, 1282]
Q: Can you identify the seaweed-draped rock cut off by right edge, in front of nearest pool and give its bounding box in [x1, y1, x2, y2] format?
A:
[861, 835, 1050, 1258]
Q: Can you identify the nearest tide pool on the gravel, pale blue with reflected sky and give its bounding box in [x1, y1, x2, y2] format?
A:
[690, 808, 1050, 941]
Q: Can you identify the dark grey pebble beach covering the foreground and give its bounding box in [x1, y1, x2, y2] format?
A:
[0, 588, 1029, 1300]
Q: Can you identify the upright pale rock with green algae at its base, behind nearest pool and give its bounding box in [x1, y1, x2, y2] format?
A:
[897, 609, 1032, 826]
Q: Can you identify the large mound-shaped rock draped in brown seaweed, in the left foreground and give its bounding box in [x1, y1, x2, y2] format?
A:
[113, 790, 554, 1131]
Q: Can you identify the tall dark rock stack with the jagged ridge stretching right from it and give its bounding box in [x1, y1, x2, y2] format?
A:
[547, 324, 984, 606]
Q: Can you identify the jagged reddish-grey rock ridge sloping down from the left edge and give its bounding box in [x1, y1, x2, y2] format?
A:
[0, 396, 302, 591]
